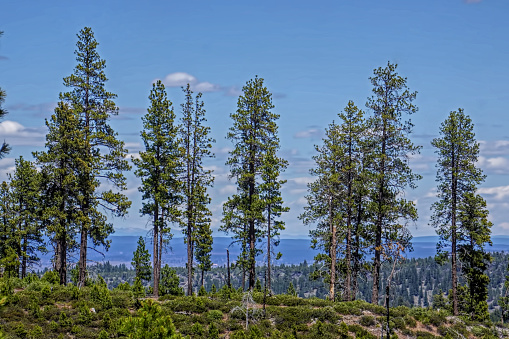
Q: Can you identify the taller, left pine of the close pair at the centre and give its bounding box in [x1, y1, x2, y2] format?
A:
[221, 77, 281, 289]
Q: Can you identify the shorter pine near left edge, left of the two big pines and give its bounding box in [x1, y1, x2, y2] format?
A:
[9, 157, 46, 278]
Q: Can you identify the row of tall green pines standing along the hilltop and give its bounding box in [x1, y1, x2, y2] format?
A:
[0, 27, 509, 321]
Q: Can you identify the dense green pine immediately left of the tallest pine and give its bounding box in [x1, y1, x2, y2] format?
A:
[34, 102, 83, 284]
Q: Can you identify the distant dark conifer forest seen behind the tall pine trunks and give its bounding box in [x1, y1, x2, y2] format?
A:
[64, 252, 509, 322]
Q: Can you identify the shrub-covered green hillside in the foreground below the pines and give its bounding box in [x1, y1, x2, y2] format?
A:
[0, 273, 509, 339]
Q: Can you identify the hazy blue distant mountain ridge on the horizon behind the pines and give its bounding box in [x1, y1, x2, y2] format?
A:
[36, 235, 509, 267]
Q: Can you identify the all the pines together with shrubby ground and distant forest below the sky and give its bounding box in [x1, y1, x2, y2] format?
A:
[0, 27, 509, 338]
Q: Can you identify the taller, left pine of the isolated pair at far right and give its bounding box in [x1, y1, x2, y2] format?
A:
[431, 108, 489, 315]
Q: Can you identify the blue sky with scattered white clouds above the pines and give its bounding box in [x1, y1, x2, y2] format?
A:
[0, 0, 509, 238]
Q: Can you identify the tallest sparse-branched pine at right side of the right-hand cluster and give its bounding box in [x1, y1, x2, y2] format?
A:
[366, 62, 420, 304]
